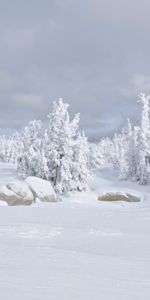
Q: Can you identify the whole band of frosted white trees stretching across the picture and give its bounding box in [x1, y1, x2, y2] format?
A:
[0, 94, 150, 194]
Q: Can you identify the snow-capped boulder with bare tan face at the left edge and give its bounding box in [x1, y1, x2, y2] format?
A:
[0, 180, 34, 205]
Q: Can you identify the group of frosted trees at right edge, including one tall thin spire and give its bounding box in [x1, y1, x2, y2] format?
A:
[108, 94, 150, 184]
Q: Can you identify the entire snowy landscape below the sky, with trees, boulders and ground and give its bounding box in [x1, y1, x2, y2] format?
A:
[0, 94, 150, 300]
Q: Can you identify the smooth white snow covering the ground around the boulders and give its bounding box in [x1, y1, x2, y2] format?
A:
[0, 164, 150, 300]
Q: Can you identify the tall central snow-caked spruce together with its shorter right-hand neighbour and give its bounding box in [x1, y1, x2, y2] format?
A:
[45, 99, 88, 193]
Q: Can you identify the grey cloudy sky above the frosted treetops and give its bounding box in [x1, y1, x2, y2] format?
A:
[0, 0, 150, 139]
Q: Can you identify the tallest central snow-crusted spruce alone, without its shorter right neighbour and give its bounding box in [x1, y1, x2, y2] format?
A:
[45, 99, 74, 191]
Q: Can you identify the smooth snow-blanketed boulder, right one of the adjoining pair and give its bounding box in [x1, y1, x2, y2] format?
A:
[25, 176, 58, 202]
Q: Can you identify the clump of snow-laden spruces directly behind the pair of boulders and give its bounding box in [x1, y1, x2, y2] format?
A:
[17, 99, 88, 194]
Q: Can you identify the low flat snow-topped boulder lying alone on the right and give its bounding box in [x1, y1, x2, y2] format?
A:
[98, 192, 141, 202]
